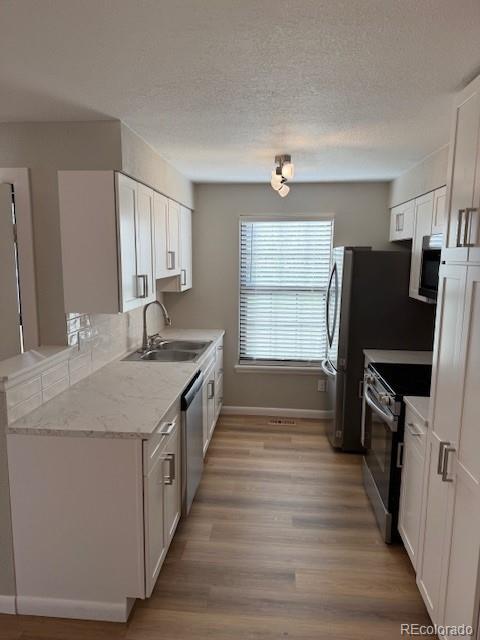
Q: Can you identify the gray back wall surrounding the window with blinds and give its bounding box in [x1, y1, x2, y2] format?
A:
[165, 183, 392, 409]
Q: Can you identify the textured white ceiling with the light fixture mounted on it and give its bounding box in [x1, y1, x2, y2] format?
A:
[0, 0, 480, 181]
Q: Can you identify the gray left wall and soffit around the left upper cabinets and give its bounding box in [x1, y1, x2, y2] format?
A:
[0, 121, 193, 345]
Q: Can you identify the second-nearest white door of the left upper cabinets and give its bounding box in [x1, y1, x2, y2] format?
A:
[136, 184, 157, 304]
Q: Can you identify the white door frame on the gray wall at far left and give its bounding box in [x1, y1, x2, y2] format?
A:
[0, 168, 39, 351]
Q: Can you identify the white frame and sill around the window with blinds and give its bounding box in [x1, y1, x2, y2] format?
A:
[235, 213, 335, 375]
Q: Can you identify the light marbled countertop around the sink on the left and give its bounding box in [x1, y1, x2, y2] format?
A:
[7, 329, 224, 438]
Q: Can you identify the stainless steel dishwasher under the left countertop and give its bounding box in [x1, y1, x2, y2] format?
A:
[181, 371, 203, 516]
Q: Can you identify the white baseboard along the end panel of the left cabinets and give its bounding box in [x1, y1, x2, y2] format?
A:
[17, 596, 133, 622]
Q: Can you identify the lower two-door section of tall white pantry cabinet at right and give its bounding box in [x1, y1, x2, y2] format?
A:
[417, 265, 480, 638]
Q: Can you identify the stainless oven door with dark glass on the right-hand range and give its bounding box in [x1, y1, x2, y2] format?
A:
[362, 384, 401, 542]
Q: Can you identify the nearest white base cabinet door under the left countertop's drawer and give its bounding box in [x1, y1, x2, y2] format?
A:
[144, 456, 166, 598]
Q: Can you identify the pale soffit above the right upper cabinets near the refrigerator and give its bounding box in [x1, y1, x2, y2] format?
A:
[390, 144, 448, 207]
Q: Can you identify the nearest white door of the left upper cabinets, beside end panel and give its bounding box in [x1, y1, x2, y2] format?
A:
[116, 173, 140, 311]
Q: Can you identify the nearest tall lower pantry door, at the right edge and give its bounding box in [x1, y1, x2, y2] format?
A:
[444, 267, 480, 626]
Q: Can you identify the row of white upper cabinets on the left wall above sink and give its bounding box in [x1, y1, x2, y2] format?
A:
[58, 171, 191, 313]
